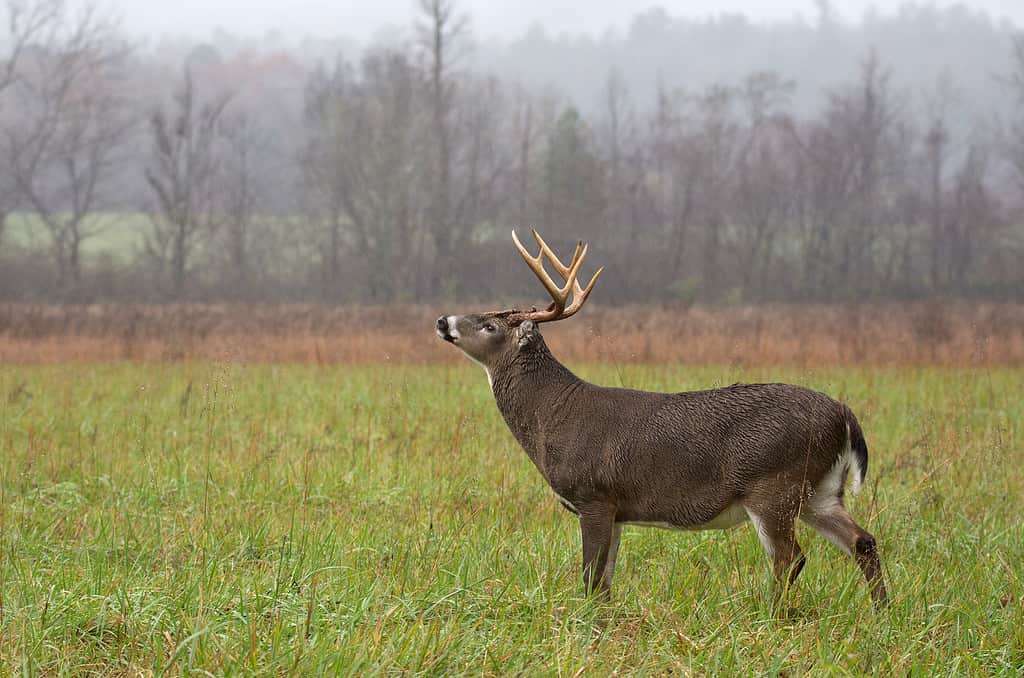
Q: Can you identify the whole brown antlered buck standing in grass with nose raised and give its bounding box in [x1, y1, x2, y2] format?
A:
[436, 230, 887, 604]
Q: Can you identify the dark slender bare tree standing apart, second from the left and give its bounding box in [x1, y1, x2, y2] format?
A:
[144, 67, 230, 299]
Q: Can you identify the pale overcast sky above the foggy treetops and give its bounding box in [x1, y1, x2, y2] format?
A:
[92, 0, 1024, 38]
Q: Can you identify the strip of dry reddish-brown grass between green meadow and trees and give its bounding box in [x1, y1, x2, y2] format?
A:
[0, 303, 1024, 366]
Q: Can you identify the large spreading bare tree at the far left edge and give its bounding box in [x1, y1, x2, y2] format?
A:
[6, 5, 134, 296]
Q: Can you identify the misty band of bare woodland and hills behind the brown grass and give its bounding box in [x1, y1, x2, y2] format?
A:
[0, 0, 1024, 304]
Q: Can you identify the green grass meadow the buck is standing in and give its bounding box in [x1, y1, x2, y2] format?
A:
[0, 364, 1024, 676]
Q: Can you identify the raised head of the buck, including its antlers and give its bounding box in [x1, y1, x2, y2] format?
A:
[436, 228, 604, 374]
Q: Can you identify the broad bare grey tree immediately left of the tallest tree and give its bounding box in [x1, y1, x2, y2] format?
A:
[303, 51, 424, 301]
